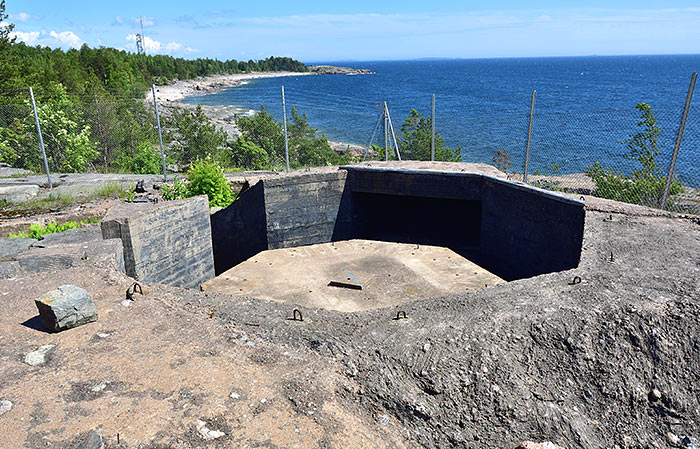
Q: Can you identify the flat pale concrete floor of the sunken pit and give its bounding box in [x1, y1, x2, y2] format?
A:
[202, 240, 505, 312]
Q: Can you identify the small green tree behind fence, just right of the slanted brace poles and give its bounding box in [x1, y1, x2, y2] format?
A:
[399, 109, 462, 162]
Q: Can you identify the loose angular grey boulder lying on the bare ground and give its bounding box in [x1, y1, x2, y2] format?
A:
[34, 285, 97, 332]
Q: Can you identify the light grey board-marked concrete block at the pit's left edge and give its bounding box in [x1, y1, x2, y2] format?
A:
[101, 195, 214, 288]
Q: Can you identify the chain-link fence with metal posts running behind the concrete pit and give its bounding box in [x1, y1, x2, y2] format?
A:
[0, 75, 700, 213]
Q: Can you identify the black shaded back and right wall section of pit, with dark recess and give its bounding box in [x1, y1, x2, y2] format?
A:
[346, 167, 585, 280]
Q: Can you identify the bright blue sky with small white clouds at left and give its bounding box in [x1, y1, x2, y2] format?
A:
[6, 0, 700, 62]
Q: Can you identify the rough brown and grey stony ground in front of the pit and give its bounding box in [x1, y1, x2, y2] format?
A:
[0, 165, 700, 449]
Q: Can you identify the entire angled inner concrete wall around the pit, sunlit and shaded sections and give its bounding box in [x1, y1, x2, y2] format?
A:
[212, 166, 584, 280]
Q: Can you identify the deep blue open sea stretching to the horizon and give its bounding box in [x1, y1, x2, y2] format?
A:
[186, 55, 700, 187]
